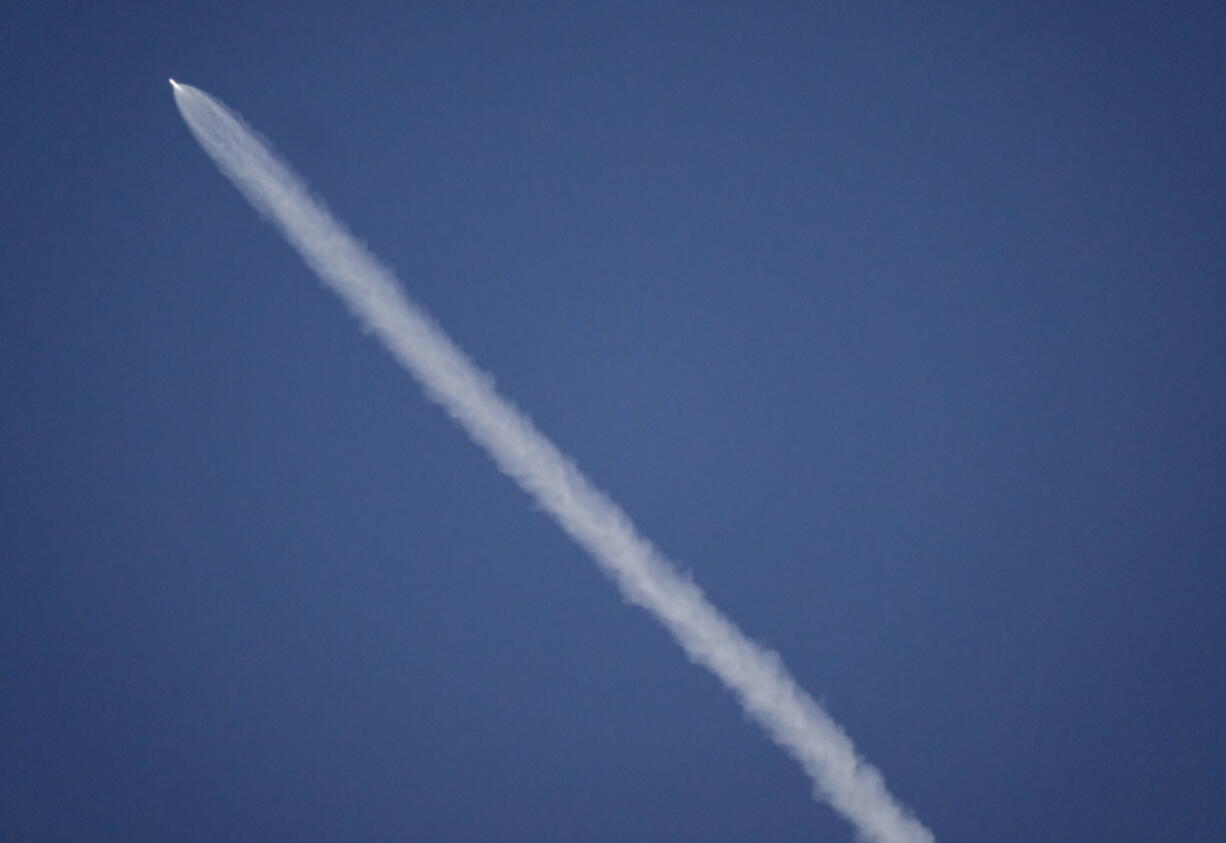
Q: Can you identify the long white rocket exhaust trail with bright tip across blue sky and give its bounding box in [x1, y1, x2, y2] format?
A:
[170, 80, 934, 843]
